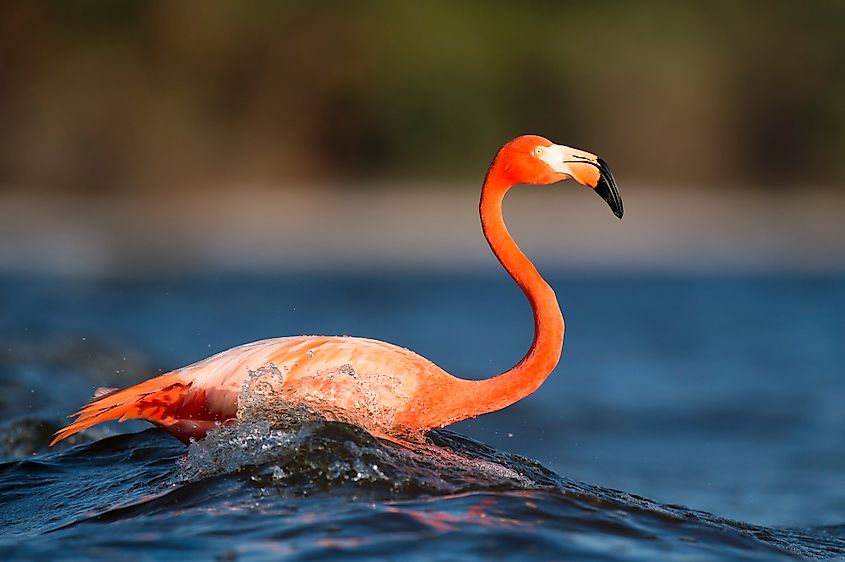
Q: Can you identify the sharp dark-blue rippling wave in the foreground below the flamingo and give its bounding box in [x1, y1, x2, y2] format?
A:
[0, 370, 845, 562]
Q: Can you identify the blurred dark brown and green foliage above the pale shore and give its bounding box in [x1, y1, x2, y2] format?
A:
[0, 0, 845, 191]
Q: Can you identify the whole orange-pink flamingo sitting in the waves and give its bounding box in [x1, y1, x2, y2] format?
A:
[50, 135, 623, 445]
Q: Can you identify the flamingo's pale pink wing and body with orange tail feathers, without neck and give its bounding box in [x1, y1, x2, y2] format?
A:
[51, 336, 436, 445]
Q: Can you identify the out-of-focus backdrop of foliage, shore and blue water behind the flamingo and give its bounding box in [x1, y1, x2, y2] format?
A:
[0, 0, 845, 525]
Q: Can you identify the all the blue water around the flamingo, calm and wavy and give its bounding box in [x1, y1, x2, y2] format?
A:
[0, 272, 845, 561]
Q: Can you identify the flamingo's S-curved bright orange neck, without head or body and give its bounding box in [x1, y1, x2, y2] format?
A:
[458, 165, 564, 417]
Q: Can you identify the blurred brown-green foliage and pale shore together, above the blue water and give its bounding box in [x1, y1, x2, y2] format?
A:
[0, 0, 845, 274]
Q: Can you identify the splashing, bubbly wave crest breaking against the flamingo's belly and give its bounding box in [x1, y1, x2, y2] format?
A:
[179, 364, 542, 497]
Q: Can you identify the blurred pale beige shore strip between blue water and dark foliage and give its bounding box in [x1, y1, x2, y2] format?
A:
[0, 184, 845, 277]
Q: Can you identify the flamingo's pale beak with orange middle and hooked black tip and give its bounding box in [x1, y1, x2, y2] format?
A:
[540, 145, 625, 219]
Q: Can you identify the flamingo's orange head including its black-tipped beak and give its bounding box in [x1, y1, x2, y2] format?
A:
[493, 135, 624, 219]
